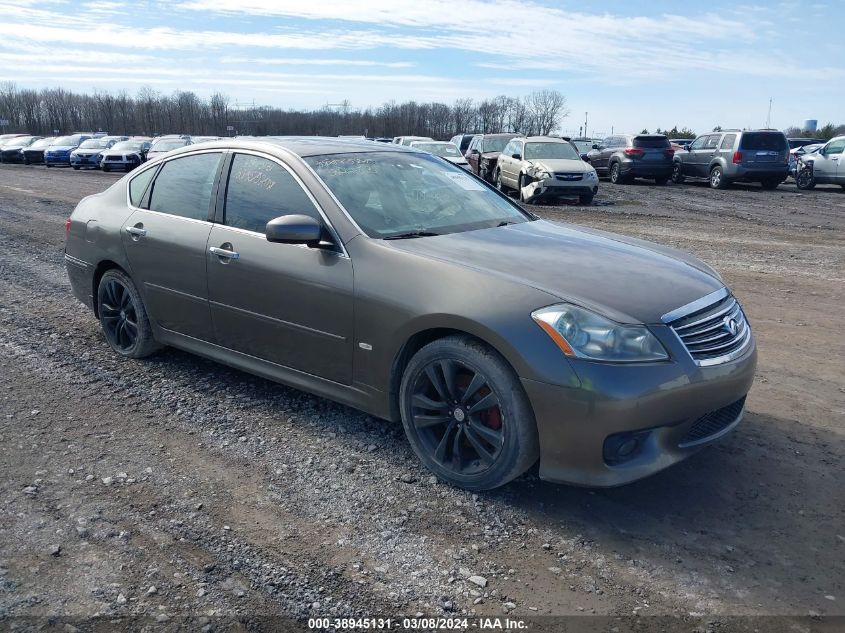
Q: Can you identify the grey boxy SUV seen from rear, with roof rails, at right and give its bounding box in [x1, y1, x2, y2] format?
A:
[672, 130, 789, 189]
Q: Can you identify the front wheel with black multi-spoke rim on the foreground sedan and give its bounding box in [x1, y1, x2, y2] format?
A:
[399, 336, 540, 490]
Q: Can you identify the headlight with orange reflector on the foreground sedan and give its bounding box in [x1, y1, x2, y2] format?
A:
[531, 303, 669, 362]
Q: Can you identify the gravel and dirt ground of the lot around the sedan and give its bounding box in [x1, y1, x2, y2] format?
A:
[0, 165, 845, 631]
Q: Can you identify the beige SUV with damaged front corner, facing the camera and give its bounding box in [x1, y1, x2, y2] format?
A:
[495, 136, 599, 204]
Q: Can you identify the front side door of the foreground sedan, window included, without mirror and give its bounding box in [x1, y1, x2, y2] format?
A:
[206, 152, 353, 384]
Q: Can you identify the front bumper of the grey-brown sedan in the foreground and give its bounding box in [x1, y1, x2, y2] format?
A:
[522, 332, 757, 487]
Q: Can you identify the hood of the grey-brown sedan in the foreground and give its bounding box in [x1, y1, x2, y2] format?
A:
[390, 220, 724, 323]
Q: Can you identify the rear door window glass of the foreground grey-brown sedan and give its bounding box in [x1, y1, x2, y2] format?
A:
[150, 152, 222, 220]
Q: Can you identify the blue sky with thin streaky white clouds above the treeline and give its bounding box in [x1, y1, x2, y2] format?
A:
[0, 0, 845, 135]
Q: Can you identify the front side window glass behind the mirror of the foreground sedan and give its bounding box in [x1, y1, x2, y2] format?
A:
[223, 154, 323, 233]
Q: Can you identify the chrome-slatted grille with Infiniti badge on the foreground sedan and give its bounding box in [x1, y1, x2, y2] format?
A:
[668, 293, 751, 365]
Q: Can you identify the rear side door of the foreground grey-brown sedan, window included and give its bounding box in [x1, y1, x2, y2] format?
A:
[121, 151, 223, 341]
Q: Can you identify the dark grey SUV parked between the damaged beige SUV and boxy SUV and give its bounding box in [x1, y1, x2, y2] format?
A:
[587, 134, 675, 185]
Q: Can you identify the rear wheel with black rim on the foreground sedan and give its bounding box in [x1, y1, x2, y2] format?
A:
[97, 268, 161, 358]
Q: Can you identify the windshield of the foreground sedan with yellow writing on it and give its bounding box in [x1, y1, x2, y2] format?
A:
[306, 152, 529, 239]
